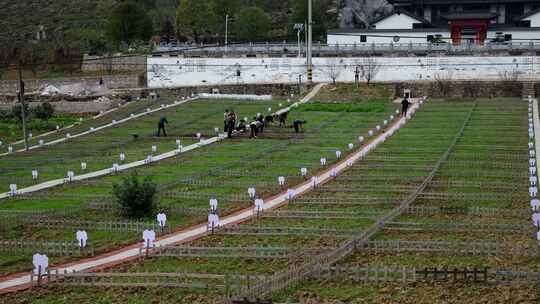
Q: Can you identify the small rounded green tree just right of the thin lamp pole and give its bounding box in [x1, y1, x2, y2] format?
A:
[234, 7, 271, 41]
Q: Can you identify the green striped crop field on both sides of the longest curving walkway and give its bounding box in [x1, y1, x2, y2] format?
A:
[0, 95, 538, 303]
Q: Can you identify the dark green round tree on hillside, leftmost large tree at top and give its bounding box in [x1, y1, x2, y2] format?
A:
[106, 1, 153, 45]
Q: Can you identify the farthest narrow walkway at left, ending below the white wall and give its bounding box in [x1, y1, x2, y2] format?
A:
[0, 97, 199, 157]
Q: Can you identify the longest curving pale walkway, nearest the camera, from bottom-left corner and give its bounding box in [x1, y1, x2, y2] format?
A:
[0, 96, 420, 294]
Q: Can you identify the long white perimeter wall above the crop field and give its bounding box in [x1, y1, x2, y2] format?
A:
[148, 56, 540, 88]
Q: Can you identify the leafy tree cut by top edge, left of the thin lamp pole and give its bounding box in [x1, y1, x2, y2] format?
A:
[176, 0, 216, 42]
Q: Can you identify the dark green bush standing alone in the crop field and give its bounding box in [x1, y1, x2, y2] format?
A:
[113, 172, 157, 218]
